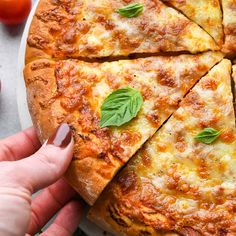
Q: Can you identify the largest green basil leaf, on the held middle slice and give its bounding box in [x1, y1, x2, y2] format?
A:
[100, 87, 143, 128]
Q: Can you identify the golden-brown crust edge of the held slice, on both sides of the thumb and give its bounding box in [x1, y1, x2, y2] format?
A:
[24, 59, 120, 205]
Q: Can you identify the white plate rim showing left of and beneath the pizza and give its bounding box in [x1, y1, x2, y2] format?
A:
[16, 0, 109, 236]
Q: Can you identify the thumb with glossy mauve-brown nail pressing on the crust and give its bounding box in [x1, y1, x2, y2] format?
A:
[11, 124, 74, 192]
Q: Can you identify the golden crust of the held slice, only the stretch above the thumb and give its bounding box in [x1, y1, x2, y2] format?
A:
[24, 59, 59, 143]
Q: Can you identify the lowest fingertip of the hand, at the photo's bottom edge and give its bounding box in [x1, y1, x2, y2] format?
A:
[40, 201, 82, 236]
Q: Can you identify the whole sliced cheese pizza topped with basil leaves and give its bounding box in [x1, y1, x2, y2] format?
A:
[24, 0, 236, 236]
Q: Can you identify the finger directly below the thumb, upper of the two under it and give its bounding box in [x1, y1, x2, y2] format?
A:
[28, 179, 76, 235]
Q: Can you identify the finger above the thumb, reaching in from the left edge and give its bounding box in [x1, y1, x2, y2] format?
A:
[0, 127, 41, 161]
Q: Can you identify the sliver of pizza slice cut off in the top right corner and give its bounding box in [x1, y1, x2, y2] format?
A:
[222, 0, 236, 54]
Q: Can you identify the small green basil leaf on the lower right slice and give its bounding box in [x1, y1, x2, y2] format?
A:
[194, 128, 222, 144]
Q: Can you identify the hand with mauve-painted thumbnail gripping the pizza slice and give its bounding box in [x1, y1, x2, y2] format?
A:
[0, 124, 81, 236]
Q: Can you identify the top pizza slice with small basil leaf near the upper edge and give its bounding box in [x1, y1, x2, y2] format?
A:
[26, 0, 219, 62]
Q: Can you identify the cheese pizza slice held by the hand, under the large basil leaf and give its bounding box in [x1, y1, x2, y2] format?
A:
[25, 52, 223, 204]
